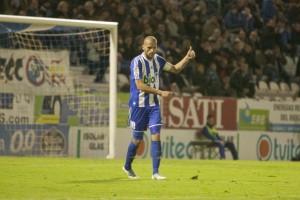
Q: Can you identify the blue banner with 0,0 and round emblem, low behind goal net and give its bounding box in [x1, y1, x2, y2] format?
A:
[0, 124, 69, 156]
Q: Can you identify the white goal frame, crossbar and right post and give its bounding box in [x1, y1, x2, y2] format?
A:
[0, 15, 118, 158]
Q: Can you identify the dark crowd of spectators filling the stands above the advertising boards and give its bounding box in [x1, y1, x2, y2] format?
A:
[0, 0, 300, 98]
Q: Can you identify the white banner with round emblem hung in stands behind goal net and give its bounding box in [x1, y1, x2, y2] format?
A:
[0, 49, 73, 95]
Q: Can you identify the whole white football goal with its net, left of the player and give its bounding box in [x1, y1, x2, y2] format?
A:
[0, 15, 117, 158]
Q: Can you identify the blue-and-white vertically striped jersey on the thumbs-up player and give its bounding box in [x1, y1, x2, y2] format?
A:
[129, 53, 166, 107]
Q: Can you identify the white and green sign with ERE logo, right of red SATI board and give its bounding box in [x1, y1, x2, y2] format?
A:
[237, 99, 300, 133]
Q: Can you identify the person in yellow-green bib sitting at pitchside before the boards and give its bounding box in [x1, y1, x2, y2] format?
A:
[202, 115, 238, 160]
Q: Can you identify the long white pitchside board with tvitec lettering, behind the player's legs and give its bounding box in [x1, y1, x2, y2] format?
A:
[116, 129, 300, 161]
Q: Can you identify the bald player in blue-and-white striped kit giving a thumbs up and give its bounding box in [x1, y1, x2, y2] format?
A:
[123, 36, 195, 180]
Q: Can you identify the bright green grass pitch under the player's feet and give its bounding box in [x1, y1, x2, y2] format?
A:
[0, 157, 300, 200]
